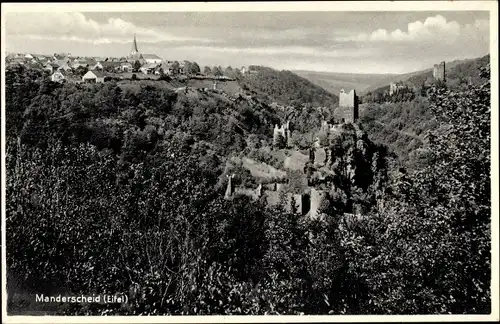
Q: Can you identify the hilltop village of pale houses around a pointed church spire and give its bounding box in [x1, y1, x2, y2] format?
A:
[6, 35, 256, 89]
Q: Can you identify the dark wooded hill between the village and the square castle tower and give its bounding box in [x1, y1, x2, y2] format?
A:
[238, 66, 338, 106]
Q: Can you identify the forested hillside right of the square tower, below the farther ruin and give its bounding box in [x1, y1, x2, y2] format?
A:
[360, 55, 490, 168]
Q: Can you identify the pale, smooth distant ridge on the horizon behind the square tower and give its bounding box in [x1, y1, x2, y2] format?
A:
[293, 55, 489, 95]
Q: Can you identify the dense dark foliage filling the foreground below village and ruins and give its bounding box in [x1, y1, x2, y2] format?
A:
[6, 62, 491, 314]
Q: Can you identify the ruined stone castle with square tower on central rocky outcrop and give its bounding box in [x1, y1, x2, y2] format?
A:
[225, 89, 366, 220]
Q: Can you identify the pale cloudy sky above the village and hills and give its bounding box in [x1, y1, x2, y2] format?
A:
[5, 11, 490, 74]
